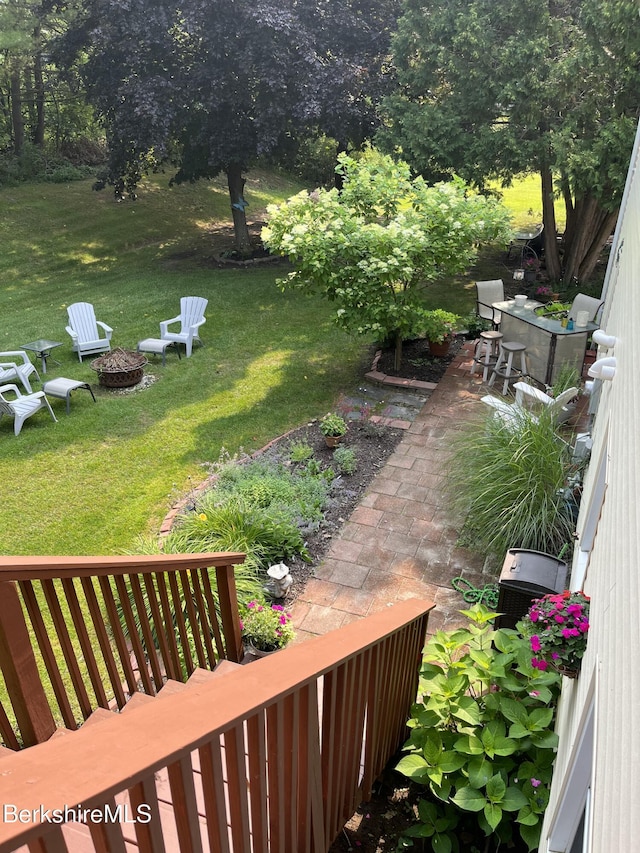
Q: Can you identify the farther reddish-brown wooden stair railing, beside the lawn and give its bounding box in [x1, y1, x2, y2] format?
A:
[0, 553, 244, 749]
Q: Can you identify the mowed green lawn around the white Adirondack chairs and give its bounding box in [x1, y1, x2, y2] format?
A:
[0, 173, 363, 554]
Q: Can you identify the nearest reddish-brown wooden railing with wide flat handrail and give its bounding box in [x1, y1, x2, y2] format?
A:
[0, 599, 433, 853]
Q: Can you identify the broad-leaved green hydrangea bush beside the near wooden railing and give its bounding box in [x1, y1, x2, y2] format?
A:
[398, 605, 560, 853]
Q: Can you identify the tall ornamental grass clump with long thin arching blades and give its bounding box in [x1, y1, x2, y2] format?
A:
[447, 412, 575, 558]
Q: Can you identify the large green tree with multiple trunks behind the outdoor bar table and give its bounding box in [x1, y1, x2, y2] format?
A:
[383, 0, 640, 282]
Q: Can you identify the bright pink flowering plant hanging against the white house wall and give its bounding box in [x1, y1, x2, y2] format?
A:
[519, 590, 589, 671]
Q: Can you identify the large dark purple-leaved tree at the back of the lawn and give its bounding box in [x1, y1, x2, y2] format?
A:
[60, 0, 398, 251]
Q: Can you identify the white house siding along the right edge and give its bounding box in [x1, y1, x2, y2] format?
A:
[540, 121, 640, 853]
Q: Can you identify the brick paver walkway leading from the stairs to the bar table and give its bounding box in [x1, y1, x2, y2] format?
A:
[293, 343, 584, 640]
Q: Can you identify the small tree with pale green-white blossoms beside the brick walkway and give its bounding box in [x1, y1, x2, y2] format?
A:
[262, 152, 510, 368]
